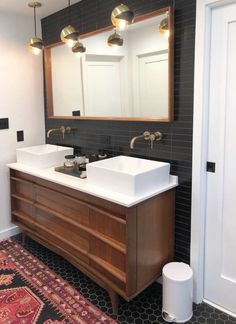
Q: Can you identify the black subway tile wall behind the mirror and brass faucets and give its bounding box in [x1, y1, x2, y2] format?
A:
[42, 0, 196, 263]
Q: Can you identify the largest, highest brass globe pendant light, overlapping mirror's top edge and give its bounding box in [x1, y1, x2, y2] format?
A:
[111, 4, 134, 31]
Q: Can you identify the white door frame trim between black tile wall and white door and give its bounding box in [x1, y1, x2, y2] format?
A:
[190, 0, 236, 303]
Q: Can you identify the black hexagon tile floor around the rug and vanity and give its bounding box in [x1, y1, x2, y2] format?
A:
[11, 235, 236, 324]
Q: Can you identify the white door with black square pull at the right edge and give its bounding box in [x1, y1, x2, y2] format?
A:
[204, 3, 236, 313]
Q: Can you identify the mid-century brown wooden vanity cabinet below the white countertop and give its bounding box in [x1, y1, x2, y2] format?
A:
[10, 169, 175, 311]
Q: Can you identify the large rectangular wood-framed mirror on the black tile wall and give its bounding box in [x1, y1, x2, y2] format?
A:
[44, 7, 174, 122]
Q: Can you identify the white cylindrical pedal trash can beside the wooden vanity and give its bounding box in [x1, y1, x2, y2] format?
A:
[162, 262, 193, 323]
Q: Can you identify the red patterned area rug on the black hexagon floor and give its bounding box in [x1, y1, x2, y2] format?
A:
[0, 240, 117, 324]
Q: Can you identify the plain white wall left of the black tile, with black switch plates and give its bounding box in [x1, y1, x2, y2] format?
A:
[0, 12, 45, 239]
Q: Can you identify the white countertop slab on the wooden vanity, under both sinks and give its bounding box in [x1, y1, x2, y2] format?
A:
[8, 163, 178, 207]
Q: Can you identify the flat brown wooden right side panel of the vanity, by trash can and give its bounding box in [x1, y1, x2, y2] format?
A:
[137, 190, 175, 290]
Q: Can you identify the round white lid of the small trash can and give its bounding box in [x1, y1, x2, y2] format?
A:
[162, 262, 193, 282]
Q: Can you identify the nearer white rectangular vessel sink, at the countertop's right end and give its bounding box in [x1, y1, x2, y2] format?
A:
[87, 155, 170, 196]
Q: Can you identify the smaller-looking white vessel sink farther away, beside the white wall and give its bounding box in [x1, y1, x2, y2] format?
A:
[16, 144, 74, 169]
